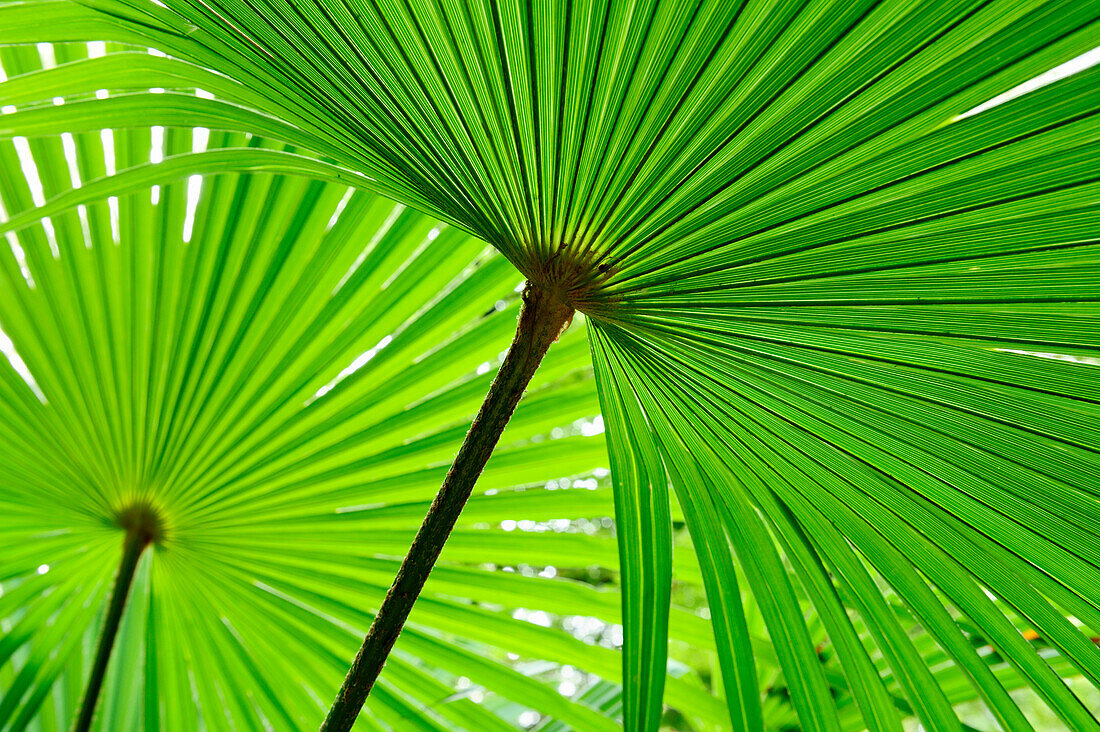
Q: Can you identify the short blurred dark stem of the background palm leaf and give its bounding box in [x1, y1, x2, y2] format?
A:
[73, 505, 160, 732]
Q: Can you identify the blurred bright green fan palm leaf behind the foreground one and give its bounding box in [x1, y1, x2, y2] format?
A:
[0, 45, 748, 730]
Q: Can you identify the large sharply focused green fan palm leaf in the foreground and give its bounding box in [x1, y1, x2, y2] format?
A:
[0, 0, 1100, 730]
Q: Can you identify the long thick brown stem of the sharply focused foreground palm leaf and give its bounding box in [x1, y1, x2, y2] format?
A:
[321, 282, 573, 732]
